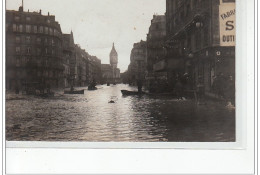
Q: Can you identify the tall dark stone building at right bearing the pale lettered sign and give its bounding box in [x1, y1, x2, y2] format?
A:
[167, 0, 235, 95]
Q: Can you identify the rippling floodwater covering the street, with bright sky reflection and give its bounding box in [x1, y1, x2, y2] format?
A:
[6, 84, 235, 142]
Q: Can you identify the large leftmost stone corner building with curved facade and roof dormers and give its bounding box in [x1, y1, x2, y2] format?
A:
[5, 6, 64, 89]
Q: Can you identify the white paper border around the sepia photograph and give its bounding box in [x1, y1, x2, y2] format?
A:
[1, 0, 258, 174]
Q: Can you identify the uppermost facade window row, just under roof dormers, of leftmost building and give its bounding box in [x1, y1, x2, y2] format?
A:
[13, 24, 61, 36]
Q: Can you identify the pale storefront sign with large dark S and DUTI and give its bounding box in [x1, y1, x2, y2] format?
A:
[219, 3, 236, 46]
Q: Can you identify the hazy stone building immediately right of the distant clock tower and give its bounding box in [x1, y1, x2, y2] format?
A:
[128, 40, 146, 85]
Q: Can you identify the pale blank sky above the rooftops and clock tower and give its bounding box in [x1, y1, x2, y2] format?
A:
[6, 0, 166, 72]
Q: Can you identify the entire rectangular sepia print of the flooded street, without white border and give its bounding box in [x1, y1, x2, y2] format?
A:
[5, 0, 236, 142]
